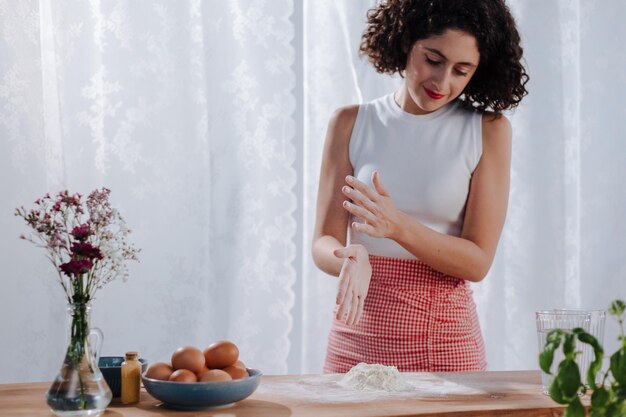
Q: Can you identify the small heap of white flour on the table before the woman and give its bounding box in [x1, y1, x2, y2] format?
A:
[338, 362, 412, 392]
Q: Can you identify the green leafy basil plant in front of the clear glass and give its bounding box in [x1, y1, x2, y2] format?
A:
[539, 300, 626, 417]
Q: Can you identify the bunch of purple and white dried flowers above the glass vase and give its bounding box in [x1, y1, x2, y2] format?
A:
[15, 188, 139, 303]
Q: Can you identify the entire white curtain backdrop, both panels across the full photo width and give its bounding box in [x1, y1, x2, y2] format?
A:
[0, 0, 626, 383]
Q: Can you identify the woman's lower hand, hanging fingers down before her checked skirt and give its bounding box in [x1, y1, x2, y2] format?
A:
[333, 245, 372, 325]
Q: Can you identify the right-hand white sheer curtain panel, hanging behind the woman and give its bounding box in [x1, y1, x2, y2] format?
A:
[303, 0, 626, 372]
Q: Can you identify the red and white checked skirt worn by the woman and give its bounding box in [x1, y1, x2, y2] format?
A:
[324, 256, 487, 373]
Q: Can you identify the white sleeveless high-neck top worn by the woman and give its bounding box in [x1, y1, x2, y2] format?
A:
[348, 94, 482, 259]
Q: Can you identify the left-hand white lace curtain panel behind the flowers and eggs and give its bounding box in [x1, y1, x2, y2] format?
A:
[0, 0, 297, 382]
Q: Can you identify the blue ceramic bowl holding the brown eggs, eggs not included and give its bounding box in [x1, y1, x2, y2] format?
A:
[141, 368, 263, 410]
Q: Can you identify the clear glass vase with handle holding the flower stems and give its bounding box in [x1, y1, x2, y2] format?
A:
[46, 303, 112, 417]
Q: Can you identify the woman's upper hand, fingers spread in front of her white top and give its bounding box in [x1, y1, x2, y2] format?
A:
[341, 171, 400, 238]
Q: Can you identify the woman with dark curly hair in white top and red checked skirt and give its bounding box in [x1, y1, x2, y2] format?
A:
[313, 0, 528, 372]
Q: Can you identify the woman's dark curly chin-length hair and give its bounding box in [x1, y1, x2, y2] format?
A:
[360, 0, 528, 114]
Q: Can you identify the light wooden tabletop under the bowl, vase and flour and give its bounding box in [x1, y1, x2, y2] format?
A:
[0, 371, 563, 417]
